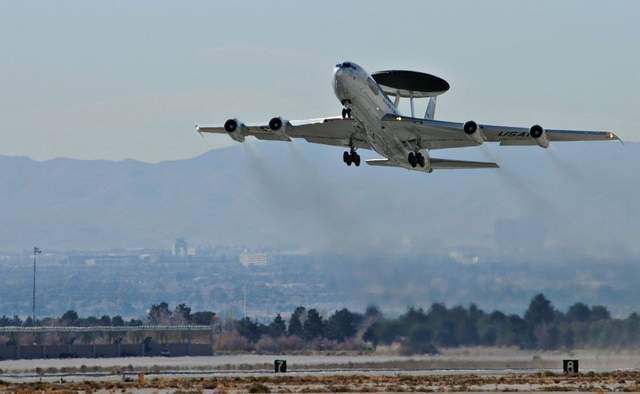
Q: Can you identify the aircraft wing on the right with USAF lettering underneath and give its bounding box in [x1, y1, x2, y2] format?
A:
[382, 114, 620, 149]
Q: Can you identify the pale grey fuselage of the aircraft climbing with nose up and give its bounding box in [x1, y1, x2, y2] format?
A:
[333, 62, 412, 161]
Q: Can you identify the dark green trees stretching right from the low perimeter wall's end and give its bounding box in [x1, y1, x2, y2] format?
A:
[225, 294, 640, 353]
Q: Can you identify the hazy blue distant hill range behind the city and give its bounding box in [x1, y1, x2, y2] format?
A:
[0, 142, 640, 262]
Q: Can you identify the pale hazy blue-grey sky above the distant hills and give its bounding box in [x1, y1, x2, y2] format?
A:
[0, 0, 640, 161]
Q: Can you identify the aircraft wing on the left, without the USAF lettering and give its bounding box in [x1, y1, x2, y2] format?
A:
[196, 117, 371, 149]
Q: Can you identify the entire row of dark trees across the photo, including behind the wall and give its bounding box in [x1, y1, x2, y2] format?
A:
[0, 294, 640, 353]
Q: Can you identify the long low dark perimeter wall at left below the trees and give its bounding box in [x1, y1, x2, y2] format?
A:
[0, 343, 213, 360]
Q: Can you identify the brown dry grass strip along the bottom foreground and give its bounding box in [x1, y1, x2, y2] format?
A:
[0, 371, 640, 393]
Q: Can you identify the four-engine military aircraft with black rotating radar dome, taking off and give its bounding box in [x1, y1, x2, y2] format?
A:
[196, 62, 619, 173]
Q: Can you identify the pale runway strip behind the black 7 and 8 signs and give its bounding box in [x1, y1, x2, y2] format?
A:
[0, 348, 640, 376]
